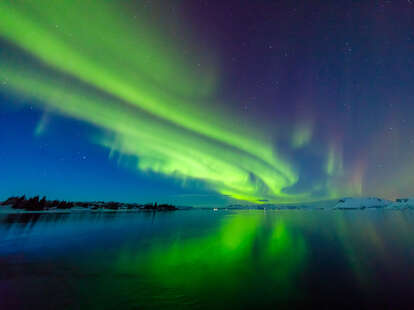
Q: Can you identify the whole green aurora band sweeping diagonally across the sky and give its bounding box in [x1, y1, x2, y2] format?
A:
[0, 0, 346, 202]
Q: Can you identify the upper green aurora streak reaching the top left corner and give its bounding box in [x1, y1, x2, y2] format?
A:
[0, 0, 284, 167]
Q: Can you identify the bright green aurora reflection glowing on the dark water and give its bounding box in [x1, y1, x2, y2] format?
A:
[116, 212, 307, 302]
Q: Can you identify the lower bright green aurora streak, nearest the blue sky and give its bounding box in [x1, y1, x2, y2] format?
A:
[0, 64, 298, 200]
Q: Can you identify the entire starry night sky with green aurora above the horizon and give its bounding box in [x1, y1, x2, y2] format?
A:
[0, 0, 414, 206]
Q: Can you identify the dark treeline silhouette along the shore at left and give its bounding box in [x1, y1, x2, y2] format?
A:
[0, 195, 177, 211]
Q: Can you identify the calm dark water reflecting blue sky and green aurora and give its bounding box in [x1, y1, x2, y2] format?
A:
[0, 210, 414, 309]
